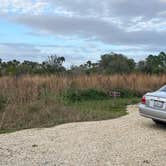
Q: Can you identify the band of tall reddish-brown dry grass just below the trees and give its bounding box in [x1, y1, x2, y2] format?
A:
[0, 74, 166, 104]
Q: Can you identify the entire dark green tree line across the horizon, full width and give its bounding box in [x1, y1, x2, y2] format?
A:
[0, 52, 166, 76]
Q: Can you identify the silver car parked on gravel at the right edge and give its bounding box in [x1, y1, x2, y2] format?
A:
[139, 86, 166, 123]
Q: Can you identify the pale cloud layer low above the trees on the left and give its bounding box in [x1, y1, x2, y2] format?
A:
[0, 43, 103, 67]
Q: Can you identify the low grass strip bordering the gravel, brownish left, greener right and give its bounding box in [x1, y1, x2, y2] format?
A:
[0, 98, 140, 133]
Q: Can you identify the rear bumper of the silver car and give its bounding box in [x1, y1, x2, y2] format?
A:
[139, 104, 166, 122]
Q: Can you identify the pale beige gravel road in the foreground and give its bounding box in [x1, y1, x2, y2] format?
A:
[0, 106, 166, 166]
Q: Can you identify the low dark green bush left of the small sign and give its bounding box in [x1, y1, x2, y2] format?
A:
[63, 89, 109, 102]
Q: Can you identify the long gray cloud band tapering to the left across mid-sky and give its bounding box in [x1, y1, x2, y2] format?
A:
[12, 15, 166, 45]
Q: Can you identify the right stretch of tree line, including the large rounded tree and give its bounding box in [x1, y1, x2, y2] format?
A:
[70, 52, 166, 74]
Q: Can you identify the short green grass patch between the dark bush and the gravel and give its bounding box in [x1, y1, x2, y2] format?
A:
[67, 98, 140, 121]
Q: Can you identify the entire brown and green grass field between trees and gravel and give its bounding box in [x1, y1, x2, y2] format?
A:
[0, 74, 166, 132]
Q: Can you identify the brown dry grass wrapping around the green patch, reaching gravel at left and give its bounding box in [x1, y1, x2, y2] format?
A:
[0, 74, 166, 129]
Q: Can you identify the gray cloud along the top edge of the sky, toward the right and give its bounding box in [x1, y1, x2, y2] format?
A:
[50, 0, 166, 18]
